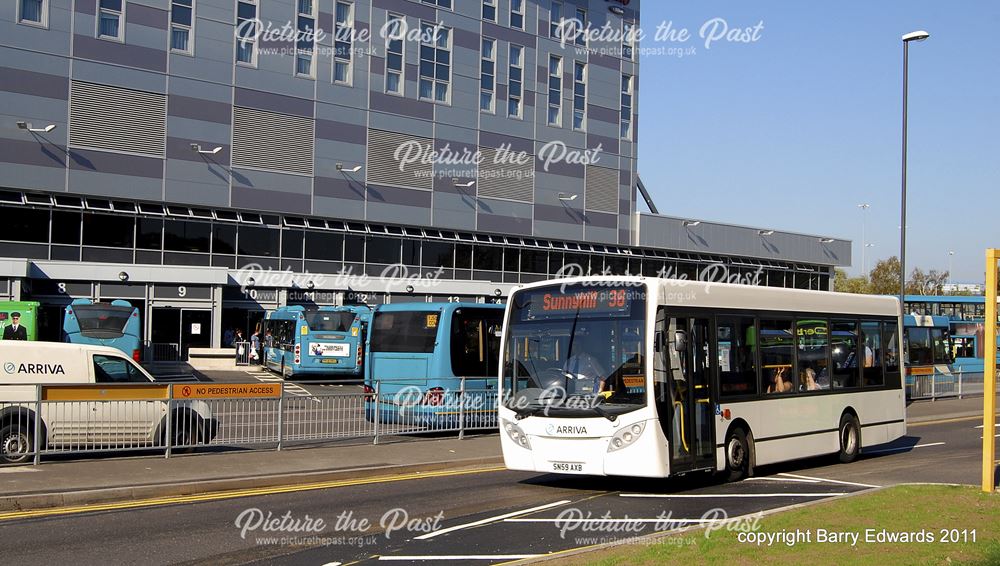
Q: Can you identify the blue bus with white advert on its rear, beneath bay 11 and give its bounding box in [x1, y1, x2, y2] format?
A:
[260, 306, 371, 379]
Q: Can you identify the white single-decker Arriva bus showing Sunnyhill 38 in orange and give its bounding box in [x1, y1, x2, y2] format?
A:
[499, 277, 906, 479]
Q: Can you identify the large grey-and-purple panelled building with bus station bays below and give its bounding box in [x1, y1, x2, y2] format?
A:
[0, 0, 851, 358]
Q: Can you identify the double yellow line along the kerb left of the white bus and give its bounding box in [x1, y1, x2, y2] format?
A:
[0, 466, 506, 521]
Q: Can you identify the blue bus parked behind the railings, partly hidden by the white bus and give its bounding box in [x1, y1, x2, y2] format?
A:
[365, 303, 504, 428]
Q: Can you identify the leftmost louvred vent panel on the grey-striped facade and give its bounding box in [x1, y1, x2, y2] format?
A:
[69, 81, 167, 157]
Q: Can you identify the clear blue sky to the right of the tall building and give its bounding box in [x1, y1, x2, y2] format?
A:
[639, 0, 1000, 282]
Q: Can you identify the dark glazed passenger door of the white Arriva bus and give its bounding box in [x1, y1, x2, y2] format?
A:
[665, 318, 715, 473]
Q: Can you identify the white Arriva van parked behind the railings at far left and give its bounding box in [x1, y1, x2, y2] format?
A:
[0, 340, 218, 463]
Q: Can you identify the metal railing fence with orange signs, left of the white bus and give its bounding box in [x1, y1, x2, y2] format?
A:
[0, 379, 497, 464]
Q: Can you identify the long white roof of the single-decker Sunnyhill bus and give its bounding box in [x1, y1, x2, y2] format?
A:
[515, 276, 899, 322]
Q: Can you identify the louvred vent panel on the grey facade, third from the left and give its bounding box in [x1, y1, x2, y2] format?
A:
[368, 130, 434, 190]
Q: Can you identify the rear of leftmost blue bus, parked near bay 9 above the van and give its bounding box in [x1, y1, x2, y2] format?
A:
[63, 299, 142, 362]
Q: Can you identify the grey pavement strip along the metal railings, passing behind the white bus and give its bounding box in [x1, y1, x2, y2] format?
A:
[0, 397, 983, 512]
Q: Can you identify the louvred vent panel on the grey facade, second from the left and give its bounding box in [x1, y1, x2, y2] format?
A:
[233, 106, 314, 175]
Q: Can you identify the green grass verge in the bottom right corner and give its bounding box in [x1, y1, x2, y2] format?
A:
[556, 485, 1000, 566]
